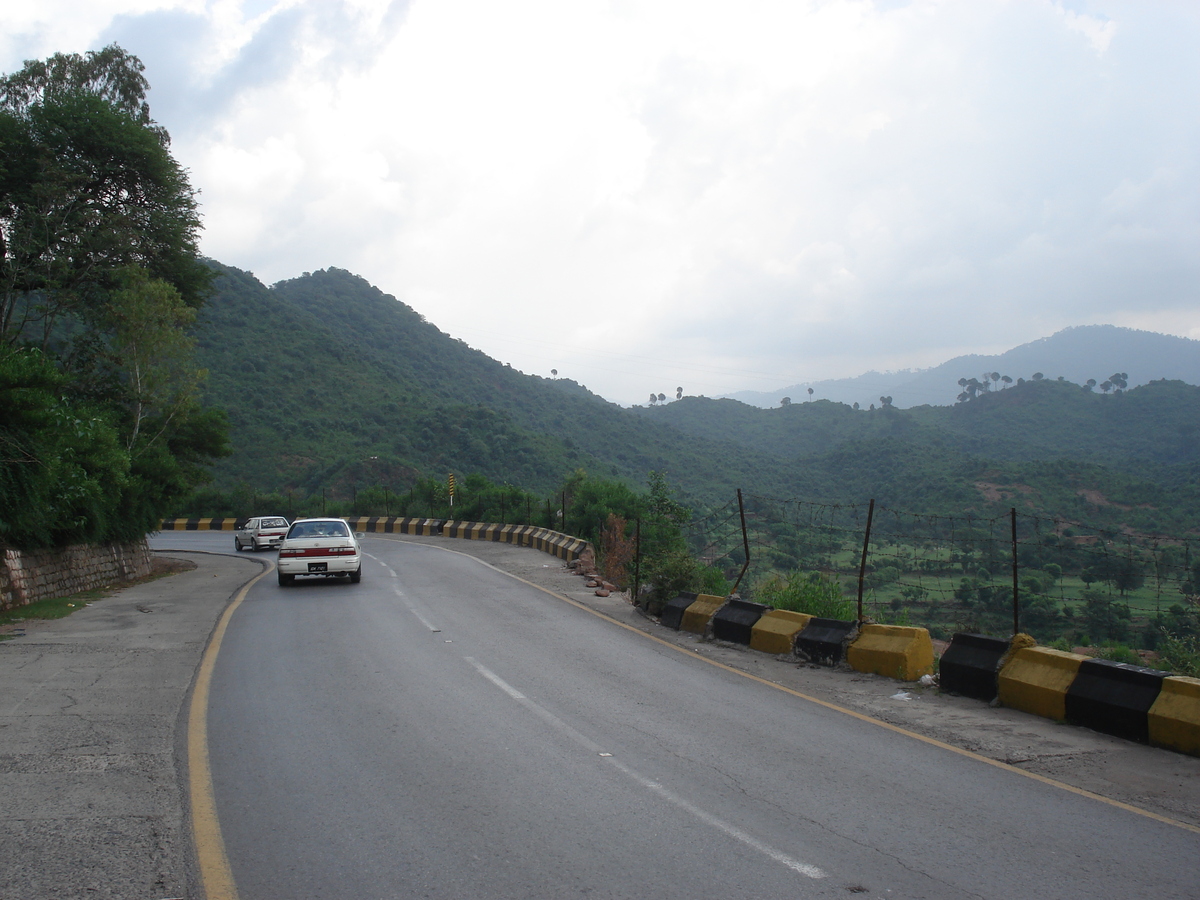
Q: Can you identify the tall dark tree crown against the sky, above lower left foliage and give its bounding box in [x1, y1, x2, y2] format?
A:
[0, 44, 212, 348]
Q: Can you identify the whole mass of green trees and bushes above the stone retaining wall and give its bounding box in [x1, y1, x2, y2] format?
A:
[0, 52, 227, 547]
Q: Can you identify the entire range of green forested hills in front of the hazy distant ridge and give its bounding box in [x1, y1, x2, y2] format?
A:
[197, 266, 1200, 530]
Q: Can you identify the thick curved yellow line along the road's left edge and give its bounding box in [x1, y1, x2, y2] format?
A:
[187, 565, 275, 900]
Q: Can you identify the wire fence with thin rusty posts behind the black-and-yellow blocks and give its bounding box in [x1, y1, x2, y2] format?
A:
[689, 494, 1200, 649]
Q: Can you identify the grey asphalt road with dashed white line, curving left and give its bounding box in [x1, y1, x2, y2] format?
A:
[158, 535, 1200, 900]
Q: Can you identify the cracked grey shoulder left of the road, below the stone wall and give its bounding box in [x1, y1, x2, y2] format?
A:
[0, 551, 265, 900]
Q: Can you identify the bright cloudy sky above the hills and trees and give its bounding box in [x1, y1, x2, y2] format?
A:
[0, 0, 1200, 404]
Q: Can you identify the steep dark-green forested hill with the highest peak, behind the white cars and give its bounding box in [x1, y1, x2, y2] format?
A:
[197, 266, 788, 508]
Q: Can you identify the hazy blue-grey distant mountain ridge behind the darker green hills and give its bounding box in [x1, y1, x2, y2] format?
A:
[724, 325, 1200, 409]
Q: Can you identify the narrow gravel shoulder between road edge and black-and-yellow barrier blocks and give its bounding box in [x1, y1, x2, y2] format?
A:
[401, 536, 1200, 828]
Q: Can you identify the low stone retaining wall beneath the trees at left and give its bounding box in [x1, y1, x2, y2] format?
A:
[0, 539, 151, 610]
